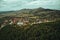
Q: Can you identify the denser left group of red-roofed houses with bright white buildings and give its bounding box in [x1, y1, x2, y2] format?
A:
[3, 17, 29, 26]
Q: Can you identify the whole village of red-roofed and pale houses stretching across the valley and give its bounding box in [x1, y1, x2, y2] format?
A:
[2, 17, 50, 26]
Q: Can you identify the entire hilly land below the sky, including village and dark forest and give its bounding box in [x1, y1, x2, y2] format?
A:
[0, 8, 60, 40]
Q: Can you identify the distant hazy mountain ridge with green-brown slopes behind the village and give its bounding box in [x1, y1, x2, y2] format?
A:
[0, 8, 60, 18]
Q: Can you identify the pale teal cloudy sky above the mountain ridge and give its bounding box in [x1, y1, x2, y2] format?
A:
[0, 0, 60, 11]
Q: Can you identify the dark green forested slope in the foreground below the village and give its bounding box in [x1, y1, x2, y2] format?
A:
[0, 21, 60, 40]
